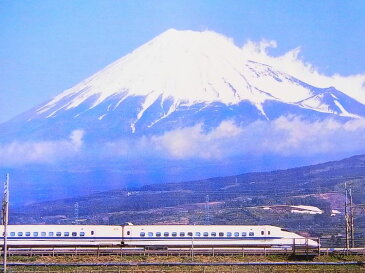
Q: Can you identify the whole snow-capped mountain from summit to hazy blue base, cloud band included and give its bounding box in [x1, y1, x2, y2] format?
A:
[0, 29, 365, 203]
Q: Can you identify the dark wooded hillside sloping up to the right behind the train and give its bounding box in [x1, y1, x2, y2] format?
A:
[11, 155, 365, 239]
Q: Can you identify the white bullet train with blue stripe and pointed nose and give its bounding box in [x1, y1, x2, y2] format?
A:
[0, 224, 318, 248]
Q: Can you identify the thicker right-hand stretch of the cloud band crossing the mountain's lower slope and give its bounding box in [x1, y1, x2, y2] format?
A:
[146, 116, 365, 160]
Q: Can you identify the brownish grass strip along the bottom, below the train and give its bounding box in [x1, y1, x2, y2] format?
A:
[4, 255, 365, 273]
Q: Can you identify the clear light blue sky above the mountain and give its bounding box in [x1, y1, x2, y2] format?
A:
[0, 0, 365, 122]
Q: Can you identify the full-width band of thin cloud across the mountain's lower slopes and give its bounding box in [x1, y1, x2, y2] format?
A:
[0, 116, 365, 166]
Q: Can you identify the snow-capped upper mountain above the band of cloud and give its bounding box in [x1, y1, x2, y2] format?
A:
[0, 29, 365, 141]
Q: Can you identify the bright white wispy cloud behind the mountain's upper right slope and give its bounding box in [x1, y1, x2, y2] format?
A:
[242, 40, 365, 104]
